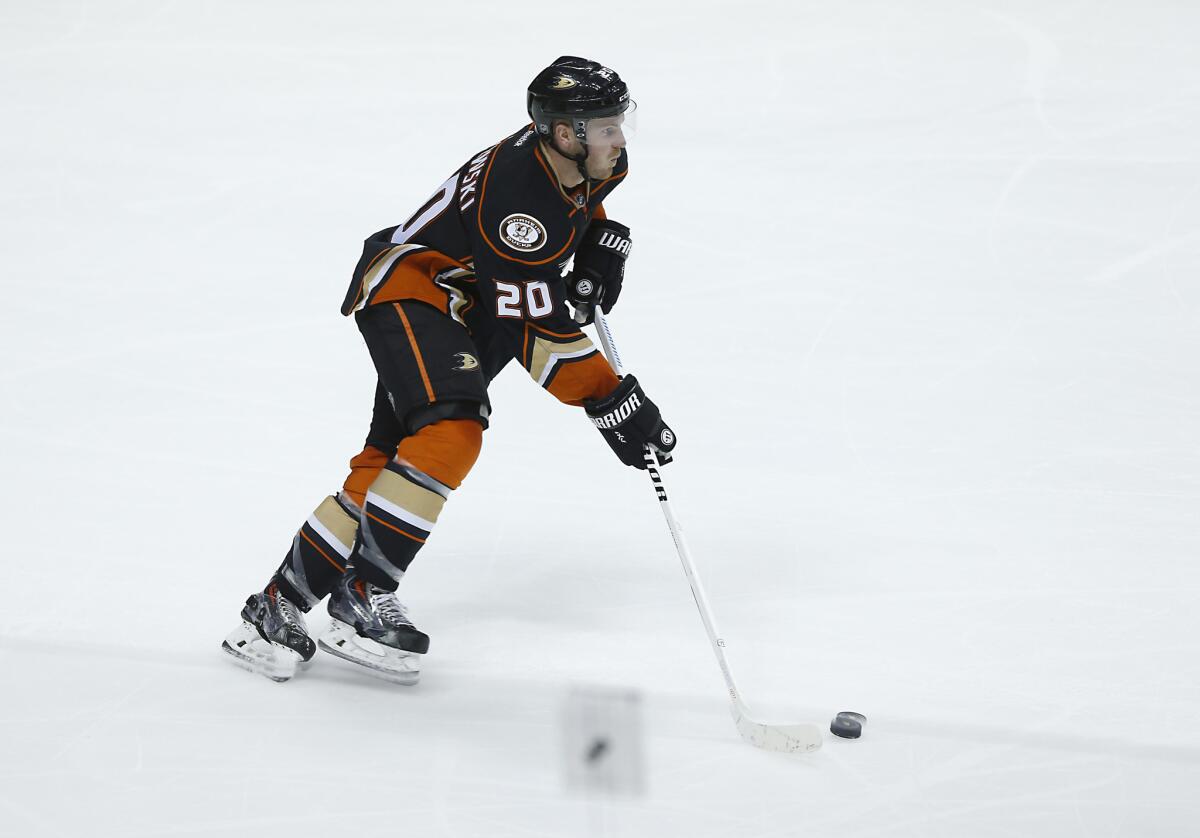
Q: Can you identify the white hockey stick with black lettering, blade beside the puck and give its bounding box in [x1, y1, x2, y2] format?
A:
[595, 309, 822, 753]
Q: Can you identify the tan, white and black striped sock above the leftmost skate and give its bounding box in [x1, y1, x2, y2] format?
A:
[271, 496, 359, 602]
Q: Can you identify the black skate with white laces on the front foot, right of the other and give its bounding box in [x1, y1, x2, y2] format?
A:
[317, 568, 430, 684]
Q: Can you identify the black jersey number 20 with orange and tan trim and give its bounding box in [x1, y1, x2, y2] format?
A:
[342, 125, 628, 403]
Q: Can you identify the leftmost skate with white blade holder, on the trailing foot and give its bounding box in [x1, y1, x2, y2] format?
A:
[221, 582, 317, 681]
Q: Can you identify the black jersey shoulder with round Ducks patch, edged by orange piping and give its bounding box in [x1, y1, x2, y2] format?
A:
[476, 126, 575, 264]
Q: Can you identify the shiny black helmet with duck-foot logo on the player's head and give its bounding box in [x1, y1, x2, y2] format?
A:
[526, 55, 636, 145]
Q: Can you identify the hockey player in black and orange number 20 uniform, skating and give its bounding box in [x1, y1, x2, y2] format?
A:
[223, 56, 676, 683]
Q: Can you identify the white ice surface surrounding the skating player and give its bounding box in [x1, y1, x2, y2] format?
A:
[0, 0, 1200, 838]
